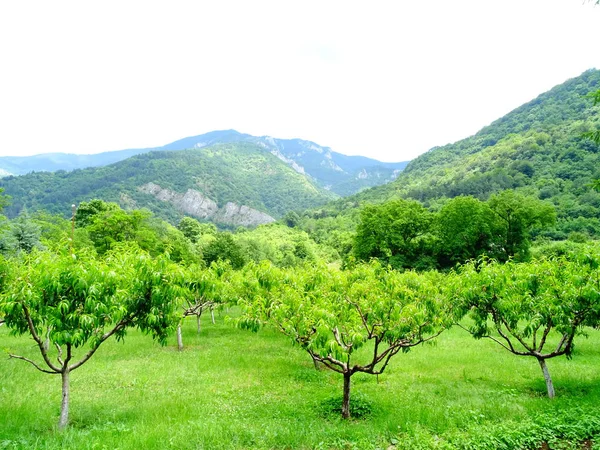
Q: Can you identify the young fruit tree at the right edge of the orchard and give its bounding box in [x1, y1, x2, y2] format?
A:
[453, 256, 600, 398]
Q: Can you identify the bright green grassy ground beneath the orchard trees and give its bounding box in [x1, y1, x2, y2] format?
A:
[0, 317, 600, 449]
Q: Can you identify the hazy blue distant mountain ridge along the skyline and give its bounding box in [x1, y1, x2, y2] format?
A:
[0, 130, 408, 195]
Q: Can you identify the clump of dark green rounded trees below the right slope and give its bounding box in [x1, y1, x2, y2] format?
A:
[354, 190, 556, 270]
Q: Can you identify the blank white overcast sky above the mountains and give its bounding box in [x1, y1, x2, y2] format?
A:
[0, 0, 600, 161]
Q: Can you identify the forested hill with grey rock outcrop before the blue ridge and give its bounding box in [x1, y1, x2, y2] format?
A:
[0, 143, 335, 226]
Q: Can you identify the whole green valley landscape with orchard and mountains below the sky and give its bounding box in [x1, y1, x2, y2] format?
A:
[0, 70, 600, 450]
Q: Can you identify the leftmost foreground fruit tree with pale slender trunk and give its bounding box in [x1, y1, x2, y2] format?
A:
[0, 249, 183, 429]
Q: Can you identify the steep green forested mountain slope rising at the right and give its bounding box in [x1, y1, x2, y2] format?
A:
[313, 69, 600, 239]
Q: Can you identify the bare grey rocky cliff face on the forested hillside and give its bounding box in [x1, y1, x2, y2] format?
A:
[138, 183, 275, 227]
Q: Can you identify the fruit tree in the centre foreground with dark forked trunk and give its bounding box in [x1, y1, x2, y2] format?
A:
[238, 263, 452, 418]
